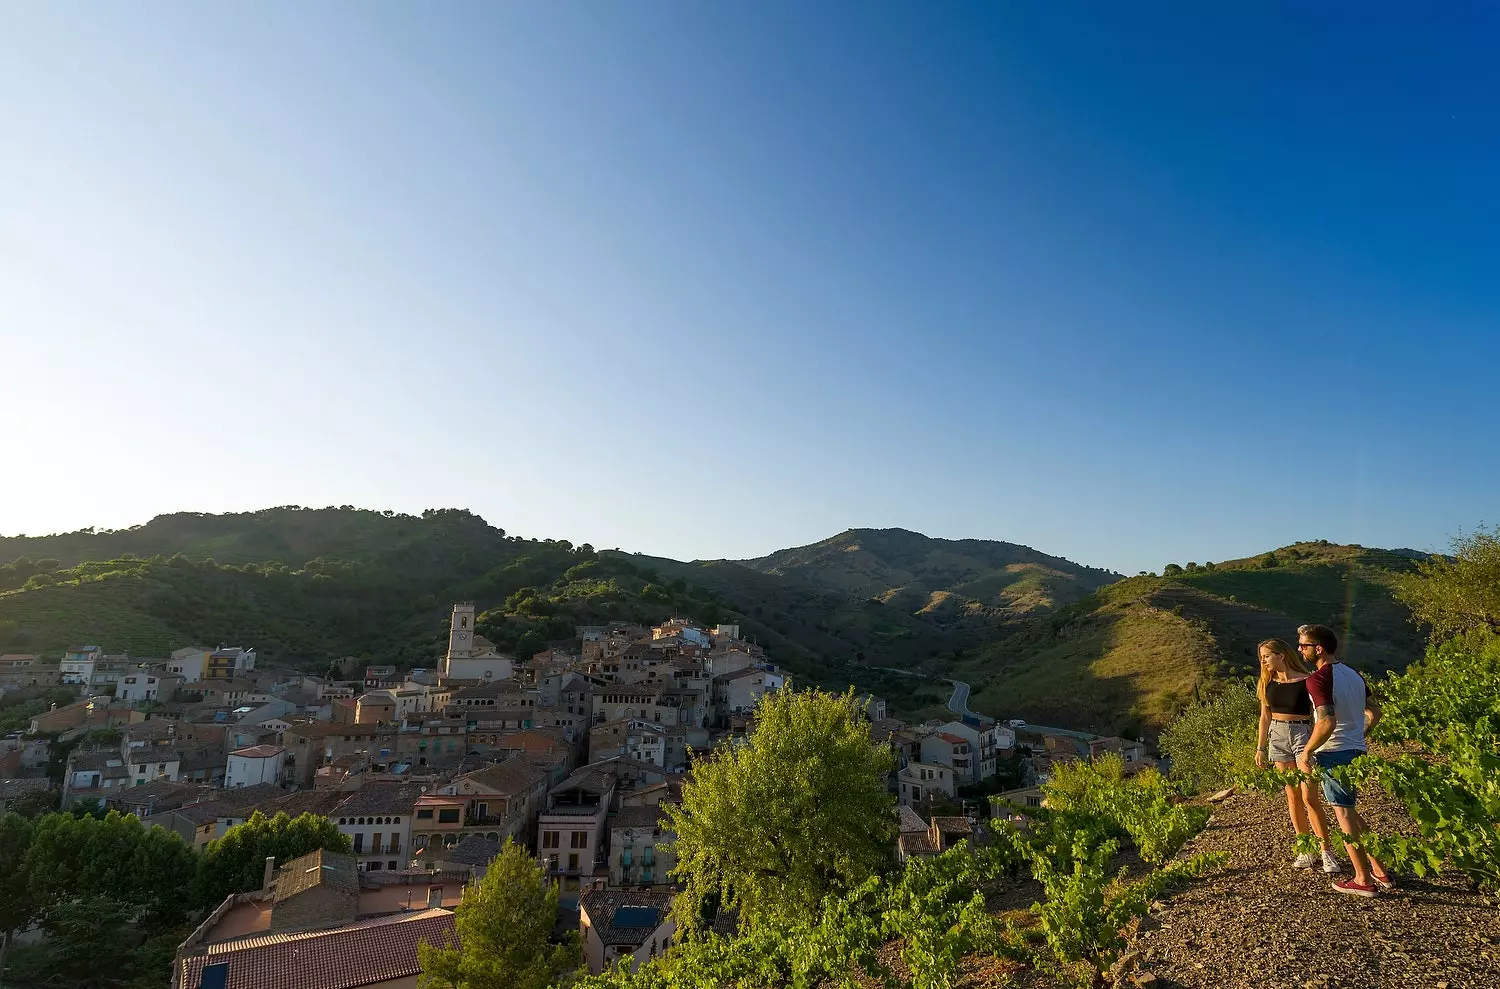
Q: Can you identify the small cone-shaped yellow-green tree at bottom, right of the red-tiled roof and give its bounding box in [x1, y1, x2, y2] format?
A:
[417, 837, 581, 989]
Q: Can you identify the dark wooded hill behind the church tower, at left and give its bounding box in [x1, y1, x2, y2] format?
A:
[0, 507, 815, 672]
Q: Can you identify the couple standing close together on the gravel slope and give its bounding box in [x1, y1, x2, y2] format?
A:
[1256, 624, 1394, 896]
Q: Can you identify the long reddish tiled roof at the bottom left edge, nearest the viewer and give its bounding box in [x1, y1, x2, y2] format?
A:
[179, 908, 456, 989]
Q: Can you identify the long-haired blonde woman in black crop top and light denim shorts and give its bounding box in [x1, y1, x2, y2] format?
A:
[1256, 639, 1340, 873]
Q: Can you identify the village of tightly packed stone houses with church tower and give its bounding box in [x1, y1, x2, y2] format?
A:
[0, 603, 1148, 987]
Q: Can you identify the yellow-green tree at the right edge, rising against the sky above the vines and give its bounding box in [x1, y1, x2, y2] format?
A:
[1397, 527, 1500, 639]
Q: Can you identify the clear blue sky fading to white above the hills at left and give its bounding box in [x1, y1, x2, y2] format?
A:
[0, 0, 1500, 572]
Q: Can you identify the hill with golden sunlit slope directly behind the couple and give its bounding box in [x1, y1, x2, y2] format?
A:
[944, 542, 1424, 732]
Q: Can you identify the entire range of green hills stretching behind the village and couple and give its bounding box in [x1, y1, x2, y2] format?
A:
[0, 507, 1422, 732]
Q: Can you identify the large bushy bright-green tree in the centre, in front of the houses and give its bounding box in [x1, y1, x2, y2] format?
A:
[666, 689, 896, 929]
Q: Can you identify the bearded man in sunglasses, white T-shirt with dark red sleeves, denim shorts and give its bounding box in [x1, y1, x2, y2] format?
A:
[1298, 624, 1394, 896]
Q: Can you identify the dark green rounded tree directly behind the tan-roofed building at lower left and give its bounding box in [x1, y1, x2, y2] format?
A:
[198, 810, 351, 906]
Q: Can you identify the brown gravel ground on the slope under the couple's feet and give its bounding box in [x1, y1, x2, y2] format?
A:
[1121, 791, 1500, 989]
